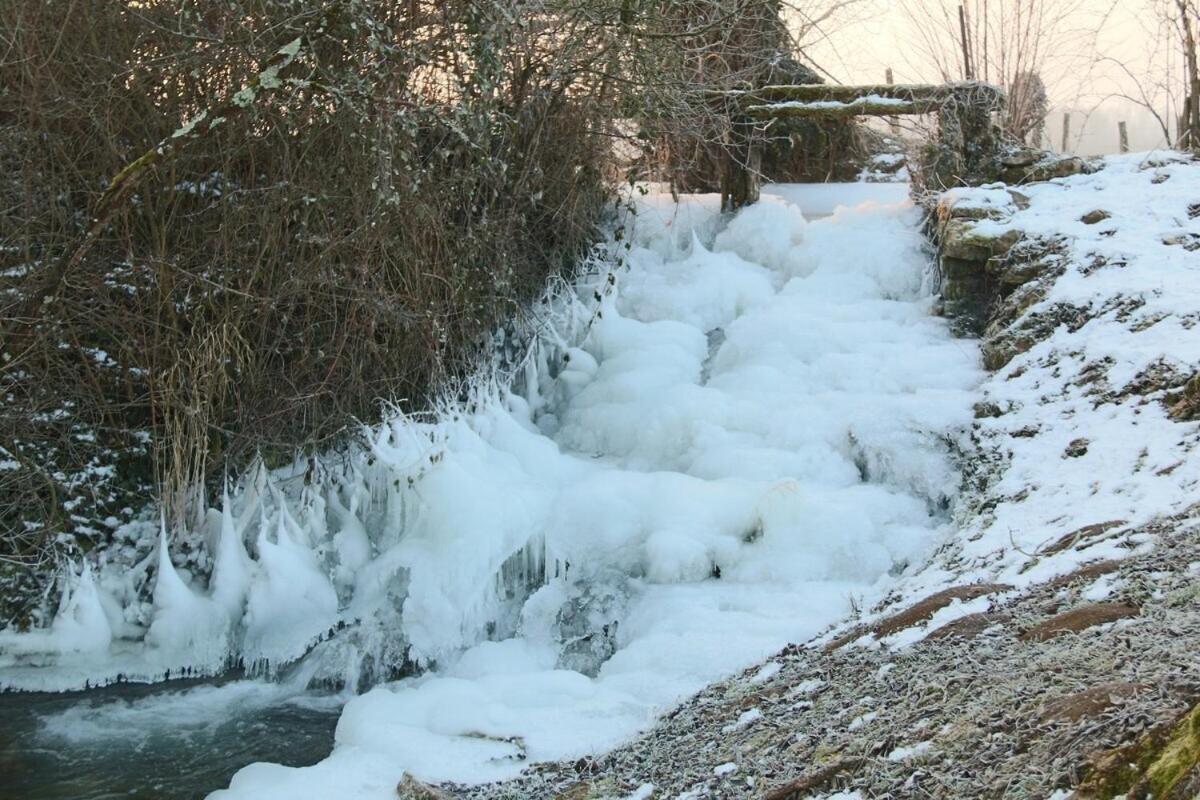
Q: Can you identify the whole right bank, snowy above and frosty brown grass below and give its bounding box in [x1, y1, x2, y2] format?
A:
[452, 154, 1200, 800]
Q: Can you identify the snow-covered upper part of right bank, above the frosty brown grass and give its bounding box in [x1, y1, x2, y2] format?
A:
[801, 152, 1200, 648]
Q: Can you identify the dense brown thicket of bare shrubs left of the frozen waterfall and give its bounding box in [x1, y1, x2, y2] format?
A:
[0, 0, 610, 575]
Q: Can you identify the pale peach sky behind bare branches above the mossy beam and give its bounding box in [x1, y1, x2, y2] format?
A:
[805, 0, 1178, 155]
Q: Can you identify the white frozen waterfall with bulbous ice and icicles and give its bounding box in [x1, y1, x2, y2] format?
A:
[0, 186, 982, 800]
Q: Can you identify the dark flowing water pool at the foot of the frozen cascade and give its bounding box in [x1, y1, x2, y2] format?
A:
[0, 680, 341, 800]
